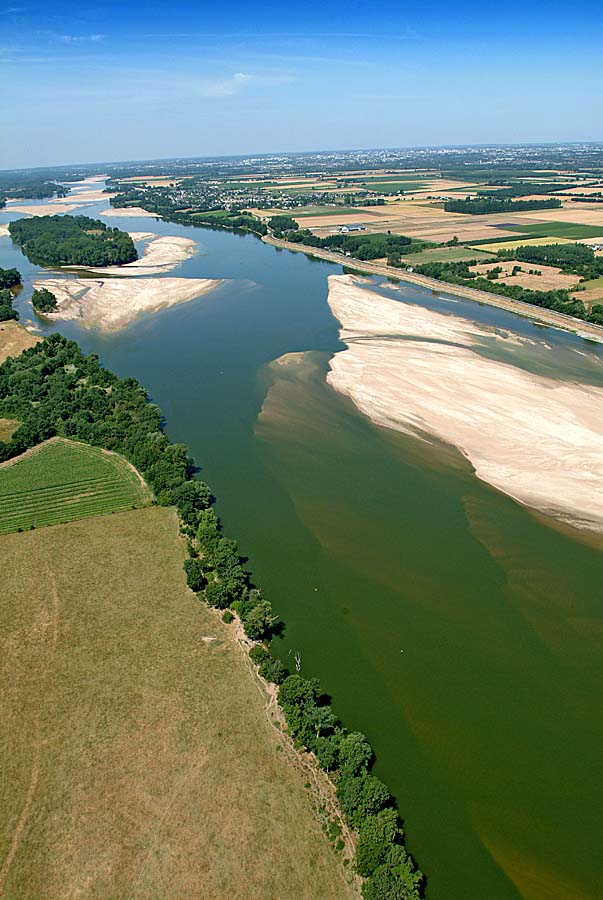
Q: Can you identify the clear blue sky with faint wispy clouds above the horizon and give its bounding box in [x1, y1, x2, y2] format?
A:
[0, 0, 603, 168]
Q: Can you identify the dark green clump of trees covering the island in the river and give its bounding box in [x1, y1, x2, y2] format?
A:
[8, 216, 138, 266]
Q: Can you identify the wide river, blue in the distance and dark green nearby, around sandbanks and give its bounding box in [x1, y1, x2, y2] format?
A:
[0, 195, 603, 900]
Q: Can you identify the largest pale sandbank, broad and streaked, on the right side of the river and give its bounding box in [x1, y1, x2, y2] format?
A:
[327, 275, 603, 531]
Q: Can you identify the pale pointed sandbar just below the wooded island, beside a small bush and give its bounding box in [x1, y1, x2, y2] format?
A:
[34, 277, 222, 331]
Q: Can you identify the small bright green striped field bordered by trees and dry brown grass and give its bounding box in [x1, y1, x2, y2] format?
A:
[0, 439, 151, 534]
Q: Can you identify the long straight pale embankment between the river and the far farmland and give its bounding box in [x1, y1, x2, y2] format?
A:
[262, 235, 603, 343]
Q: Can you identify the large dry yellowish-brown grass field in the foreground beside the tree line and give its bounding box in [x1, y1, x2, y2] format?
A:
[0, 507, 358, 900]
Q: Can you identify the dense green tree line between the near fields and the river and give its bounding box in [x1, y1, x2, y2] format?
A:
[0, 334, 424, 900]
